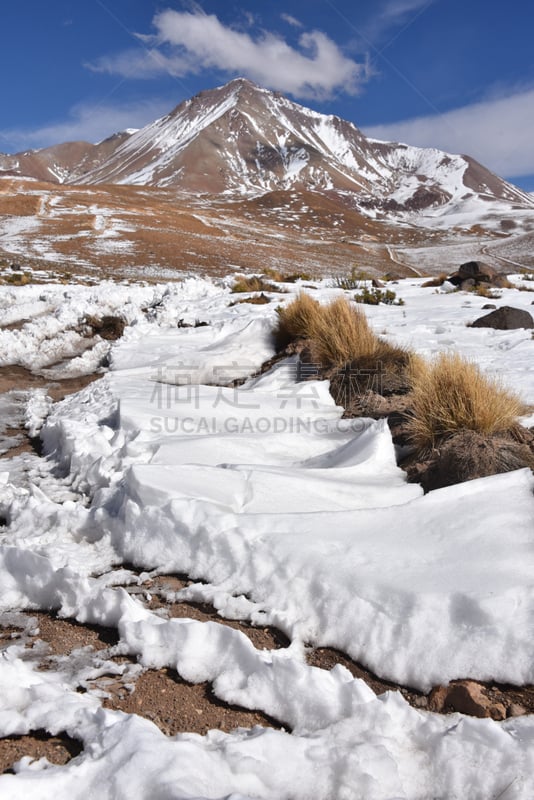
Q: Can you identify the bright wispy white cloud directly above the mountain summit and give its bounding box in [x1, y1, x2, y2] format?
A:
[90, 9, 369, 99]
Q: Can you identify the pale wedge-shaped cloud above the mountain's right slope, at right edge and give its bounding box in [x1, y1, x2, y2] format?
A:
[364, 89, 534, 178]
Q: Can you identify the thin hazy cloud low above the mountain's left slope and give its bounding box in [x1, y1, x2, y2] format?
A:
[0, 99, 172, 151]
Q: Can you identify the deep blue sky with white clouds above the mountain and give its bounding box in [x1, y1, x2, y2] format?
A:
[0, 0, 534, 191]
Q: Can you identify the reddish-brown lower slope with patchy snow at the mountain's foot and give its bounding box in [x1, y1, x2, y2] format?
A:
[0, 178, 464, 282]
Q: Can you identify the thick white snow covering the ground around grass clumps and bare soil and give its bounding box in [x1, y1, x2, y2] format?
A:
[0, 277, 534, 800]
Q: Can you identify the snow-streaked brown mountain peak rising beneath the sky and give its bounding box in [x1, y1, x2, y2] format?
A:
[0, 78, 534, 216]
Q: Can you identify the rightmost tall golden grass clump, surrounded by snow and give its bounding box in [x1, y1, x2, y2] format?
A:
[408, 353, 526, 449]
